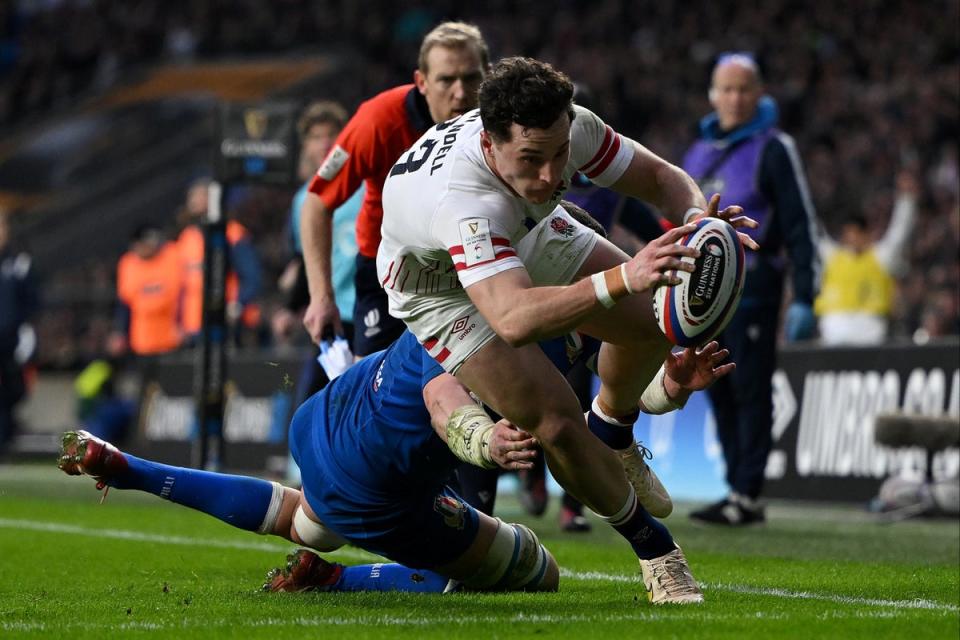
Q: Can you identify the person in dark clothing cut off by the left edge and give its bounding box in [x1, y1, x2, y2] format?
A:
[0, 209, 38, 455]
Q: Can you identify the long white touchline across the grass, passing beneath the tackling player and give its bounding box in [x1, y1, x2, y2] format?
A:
[0, 518, 960, 616]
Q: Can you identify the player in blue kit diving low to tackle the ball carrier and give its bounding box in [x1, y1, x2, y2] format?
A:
[60, 202, 734, 592]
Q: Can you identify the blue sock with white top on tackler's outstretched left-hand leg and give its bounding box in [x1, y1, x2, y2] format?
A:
[107, 453, 283, 533]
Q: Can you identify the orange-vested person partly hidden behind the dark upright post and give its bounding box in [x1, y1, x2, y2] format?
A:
[177, 178, 261, 344]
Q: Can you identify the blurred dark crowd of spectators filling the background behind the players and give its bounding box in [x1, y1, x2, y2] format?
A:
[0, 0, 960, 368]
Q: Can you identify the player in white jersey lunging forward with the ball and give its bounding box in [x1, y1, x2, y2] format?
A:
[377, 58, 756, 603]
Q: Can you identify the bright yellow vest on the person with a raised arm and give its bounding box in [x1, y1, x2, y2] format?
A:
[814, 249, 894, 316]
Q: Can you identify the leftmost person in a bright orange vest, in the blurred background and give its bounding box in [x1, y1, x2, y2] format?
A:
[108, 223, 183, 357]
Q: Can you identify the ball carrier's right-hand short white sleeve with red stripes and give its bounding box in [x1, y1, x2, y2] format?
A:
[570, 106, 633, 187]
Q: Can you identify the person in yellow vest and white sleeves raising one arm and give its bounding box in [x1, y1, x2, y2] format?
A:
[815, 172, 919, 345]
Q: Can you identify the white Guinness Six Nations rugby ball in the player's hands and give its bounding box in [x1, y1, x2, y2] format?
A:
[653, 218, 745, 347]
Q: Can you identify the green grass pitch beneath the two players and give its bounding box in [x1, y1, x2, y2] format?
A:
[0, 463, 960, 640]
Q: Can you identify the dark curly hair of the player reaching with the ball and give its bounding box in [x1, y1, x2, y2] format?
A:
[480, 57, 574, 142]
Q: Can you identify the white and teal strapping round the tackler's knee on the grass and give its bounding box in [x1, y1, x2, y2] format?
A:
[464, 520, 550, 591]
